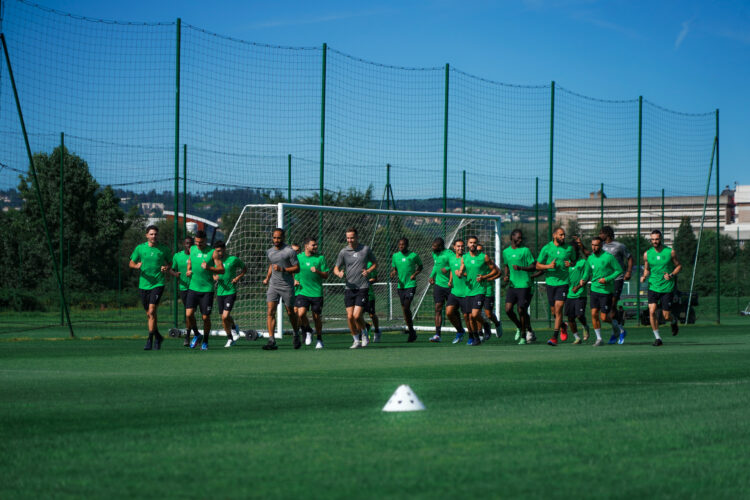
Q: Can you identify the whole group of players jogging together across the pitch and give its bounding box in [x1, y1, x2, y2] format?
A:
[130, 221, 682, 350]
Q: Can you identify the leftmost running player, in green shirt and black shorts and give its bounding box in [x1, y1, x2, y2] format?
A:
[129, 226, 172, 351]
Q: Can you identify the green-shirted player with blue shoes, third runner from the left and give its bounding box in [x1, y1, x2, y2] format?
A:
[185, 230, 224, 351]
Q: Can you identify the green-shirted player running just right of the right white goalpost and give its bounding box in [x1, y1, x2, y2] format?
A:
[503, 229, 536, 345]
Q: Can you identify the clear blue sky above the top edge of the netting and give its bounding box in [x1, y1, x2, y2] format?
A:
[7, 0, 750, 191]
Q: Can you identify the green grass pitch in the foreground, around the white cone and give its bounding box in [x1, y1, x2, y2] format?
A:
[0, 321, 750, 499]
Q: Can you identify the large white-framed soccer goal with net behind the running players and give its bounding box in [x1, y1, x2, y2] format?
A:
[227, 203, 501, 338]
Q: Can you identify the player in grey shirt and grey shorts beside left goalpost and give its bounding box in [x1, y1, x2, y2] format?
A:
[263, 227, 302, 351]
